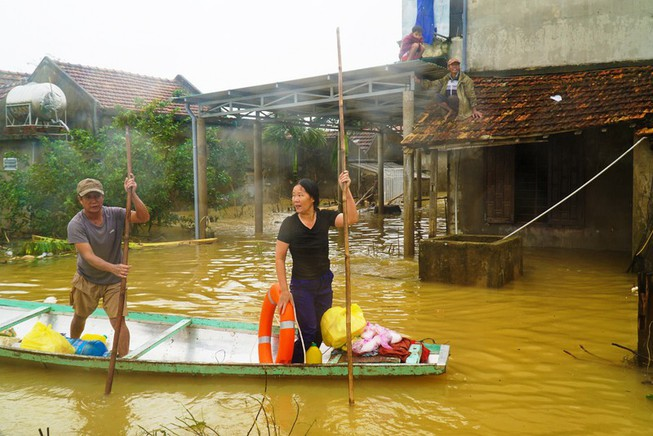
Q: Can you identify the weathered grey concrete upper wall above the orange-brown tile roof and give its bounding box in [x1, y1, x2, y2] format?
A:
[466, 0, 653, 71]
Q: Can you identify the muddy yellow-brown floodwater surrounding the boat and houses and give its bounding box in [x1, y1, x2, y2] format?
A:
[0, 210, 653, 435]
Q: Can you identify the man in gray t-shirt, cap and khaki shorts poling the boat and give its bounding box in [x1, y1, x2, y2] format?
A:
[68, 175, 150, 357]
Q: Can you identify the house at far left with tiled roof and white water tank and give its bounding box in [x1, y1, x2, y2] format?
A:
[0, 56, 200, 171]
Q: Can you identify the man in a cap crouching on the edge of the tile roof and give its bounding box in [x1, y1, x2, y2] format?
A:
[418, 58, 483, 120]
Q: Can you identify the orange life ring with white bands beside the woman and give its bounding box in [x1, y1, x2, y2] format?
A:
[258, 283, 295, 363]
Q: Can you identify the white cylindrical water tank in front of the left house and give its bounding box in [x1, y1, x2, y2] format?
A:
[7, 82, 66, 121]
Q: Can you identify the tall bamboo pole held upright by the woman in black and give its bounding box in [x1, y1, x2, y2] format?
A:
[336, 28, 354, 406]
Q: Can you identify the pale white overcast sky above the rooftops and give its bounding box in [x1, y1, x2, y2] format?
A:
[0, 0, 403, 93]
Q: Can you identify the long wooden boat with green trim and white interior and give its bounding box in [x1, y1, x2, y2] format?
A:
[0, 299, 449, 377]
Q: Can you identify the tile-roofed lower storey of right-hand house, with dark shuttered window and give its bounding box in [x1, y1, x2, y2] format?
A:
[402, 65, 653, 251]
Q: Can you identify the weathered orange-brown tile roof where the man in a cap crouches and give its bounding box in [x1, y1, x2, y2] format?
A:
[402, 66, 653, 147]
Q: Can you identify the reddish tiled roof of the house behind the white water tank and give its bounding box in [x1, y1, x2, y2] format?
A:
[46, 58, 199, 113]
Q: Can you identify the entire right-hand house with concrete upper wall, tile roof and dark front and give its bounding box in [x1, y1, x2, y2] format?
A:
[402, 0, 653, 253]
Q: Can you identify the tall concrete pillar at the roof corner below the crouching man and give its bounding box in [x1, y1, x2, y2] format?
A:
[403, 90, 415, 258]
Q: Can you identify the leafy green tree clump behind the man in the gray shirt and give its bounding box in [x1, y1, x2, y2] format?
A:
[0, 102, 247, 238]
